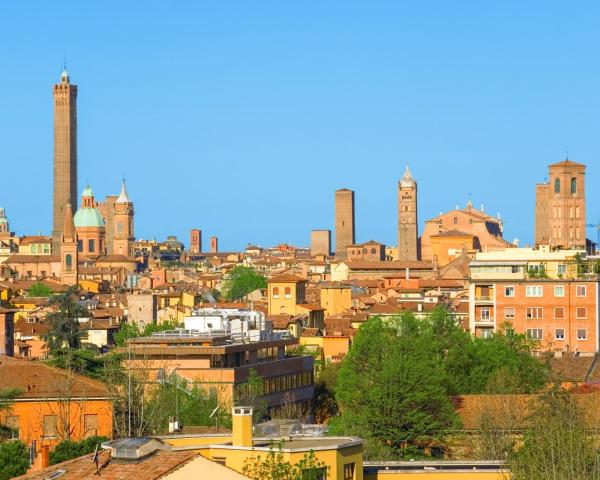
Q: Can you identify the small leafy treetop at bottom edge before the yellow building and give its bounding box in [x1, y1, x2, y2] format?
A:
[242, 442, 327, 480]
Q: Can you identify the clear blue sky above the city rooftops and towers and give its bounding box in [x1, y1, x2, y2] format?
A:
[0, 0, 600, 250]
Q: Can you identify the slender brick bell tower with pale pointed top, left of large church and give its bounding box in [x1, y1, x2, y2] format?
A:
[398, 165, 419, 261]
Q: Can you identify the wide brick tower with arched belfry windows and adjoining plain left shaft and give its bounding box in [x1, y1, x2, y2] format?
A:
[535, 159, 586, 249]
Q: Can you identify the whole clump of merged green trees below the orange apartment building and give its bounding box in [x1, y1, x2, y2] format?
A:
[330, 307, 548, 459]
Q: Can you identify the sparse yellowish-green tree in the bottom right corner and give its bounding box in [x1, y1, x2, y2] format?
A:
[508, 387, 600, 480]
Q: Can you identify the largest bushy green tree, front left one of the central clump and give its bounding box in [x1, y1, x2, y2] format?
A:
[330, 314, 459, 457]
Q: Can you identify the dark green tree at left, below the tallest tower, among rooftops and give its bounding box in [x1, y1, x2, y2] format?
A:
[44, 287, 88, 352]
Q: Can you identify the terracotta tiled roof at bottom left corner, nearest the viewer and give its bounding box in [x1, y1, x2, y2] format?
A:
[16, 450, 198, 480]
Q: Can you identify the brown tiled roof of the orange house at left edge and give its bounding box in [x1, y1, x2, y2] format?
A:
[0, 355, 108, 402]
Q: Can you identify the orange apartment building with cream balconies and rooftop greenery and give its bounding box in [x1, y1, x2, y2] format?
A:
[469, 248, 599, 352]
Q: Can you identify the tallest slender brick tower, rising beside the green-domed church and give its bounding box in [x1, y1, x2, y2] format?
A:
[52, 69, 77, 253]
